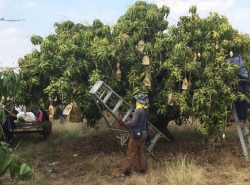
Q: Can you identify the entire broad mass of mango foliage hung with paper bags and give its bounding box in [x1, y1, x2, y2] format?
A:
[19, 1, 250, 142]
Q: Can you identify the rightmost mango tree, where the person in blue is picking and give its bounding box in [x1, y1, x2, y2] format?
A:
[156, 6, 250, 139]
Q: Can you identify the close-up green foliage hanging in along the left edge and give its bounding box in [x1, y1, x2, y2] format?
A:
[0, 68, 32, 182]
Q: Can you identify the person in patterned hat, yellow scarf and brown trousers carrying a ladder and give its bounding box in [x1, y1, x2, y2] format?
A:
[118, 93, 149, 177]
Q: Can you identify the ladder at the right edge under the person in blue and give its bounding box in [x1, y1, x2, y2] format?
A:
[232, 104, 250, 162]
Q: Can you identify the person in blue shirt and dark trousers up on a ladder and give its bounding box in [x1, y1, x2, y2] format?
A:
[225, 51, 248, 121]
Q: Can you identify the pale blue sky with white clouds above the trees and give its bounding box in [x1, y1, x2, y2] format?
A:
[0, 0, 250, 67]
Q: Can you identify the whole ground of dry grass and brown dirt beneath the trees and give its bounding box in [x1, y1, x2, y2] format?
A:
[0, 118, 250, 185]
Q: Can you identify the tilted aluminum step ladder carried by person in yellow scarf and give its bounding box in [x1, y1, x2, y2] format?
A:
[89, 81, 170, 160]
